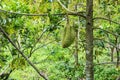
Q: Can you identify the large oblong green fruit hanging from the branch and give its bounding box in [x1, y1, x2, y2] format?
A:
[62, 25, 75, 48]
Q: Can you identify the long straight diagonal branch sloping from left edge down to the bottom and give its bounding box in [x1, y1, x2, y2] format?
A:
[0, 26, 48, 80]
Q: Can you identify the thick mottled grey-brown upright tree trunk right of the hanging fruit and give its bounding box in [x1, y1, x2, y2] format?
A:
[86, 0, 94, 80]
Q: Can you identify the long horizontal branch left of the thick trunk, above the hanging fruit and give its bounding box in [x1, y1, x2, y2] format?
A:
[0, 9, 86, 18]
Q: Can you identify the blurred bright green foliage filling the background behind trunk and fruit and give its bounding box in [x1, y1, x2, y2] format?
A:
[0, 0, 120, 80]
